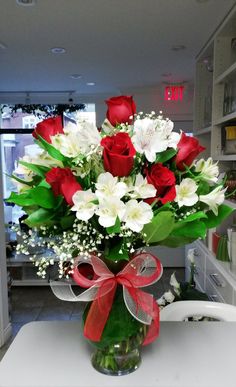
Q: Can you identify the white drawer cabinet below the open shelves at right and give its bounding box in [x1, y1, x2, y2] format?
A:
[185, 241, 236, 305]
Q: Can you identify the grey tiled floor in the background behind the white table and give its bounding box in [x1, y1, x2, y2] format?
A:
[0, 268, 184, 360]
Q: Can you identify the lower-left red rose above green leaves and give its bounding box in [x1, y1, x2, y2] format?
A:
[46, 167, 82, 206]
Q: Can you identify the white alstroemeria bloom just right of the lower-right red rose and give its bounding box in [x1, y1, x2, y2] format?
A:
[175, 178, 198, 207]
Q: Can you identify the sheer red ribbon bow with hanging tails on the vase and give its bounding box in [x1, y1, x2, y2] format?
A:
[73, 253, 162, 345]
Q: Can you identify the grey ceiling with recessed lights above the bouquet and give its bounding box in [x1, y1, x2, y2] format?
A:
[0, 0, 236, 103]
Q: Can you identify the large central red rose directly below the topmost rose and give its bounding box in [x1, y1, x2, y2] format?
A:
[101, 133, 136, 177]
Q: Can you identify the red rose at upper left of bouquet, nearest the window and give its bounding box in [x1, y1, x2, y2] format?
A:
[32, 116, 64, 143]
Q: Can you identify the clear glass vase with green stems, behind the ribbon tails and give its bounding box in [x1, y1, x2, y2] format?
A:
[84, 285, 147, 375]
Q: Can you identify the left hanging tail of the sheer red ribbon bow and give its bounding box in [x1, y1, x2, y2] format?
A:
[84, 282, 117, 342]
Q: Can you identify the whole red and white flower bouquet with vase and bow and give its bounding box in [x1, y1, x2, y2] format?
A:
[8, 96, 234, 375]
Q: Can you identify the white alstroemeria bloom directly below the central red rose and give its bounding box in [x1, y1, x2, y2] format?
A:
[96, 172, 128, 199]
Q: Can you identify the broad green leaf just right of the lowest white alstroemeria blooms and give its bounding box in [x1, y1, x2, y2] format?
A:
[142, 211, 174, 243]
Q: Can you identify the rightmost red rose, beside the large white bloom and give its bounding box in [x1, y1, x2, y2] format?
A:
[175, 132, 206, 171]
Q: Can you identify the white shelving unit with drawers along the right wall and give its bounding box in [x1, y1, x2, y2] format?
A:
[191, 6, 236, 304]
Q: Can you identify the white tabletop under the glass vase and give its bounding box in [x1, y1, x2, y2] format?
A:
[0, 321, 236, 387]
